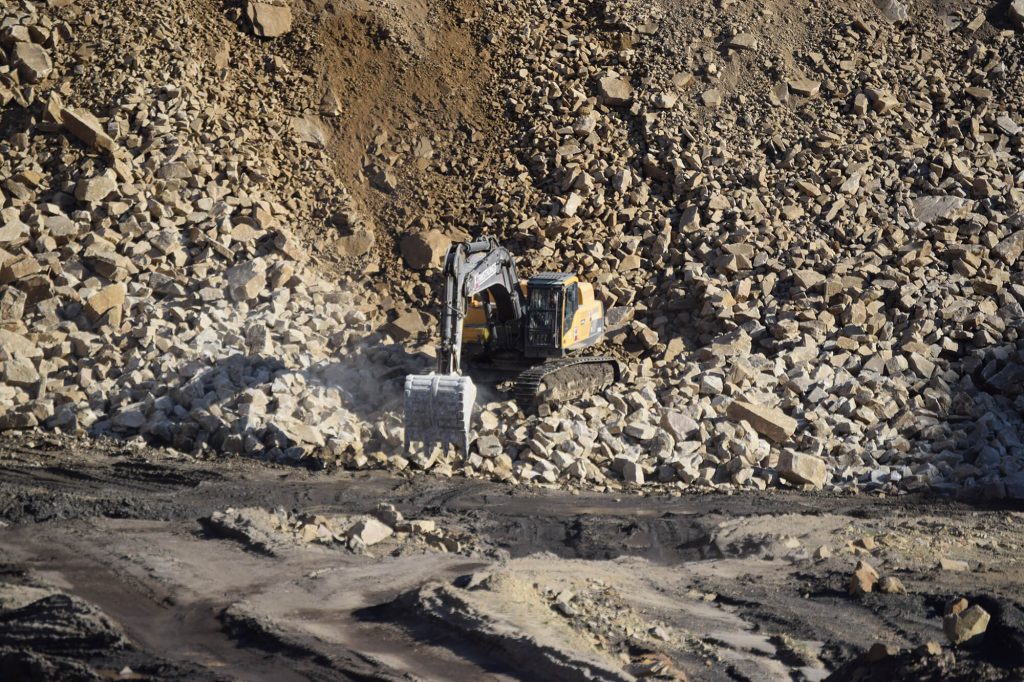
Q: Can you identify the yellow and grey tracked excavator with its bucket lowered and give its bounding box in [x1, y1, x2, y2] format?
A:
[406, 237, 622, 455]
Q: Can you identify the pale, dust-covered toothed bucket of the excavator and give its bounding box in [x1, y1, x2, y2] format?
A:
[406, 373, 476, 456]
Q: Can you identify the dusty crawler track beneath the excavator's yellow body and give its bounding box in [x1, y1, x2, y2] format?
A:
[515, 355, 621, 409]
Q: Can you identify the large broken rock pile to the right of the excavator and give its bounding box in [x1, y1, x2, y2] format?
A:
[385, 2, 1024, 497]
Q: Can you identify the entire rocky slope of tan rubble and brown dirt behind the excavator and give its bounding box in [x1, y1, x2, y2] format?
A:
[0, 0, 1024, 498]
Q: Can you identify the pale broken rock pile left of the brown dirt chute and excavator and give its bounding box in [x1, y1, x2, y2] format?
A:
[0, 4, 391, 459]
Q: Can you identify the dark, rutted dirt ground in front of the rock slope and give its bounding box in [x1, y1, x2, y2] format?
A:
[0, 435, 1024, 680]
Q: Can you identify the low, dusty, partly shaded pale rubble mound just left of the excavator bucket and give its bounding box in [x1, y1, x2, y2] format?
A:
[107, 344, 429, 468]
